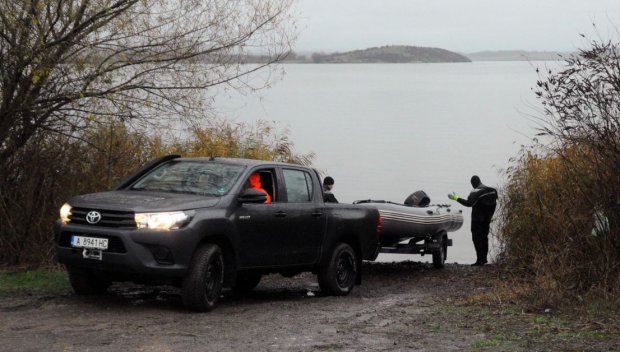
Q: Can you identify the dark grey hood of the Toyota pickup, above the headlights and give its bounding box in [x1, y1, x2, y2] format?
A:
[69, 190, 220, 212]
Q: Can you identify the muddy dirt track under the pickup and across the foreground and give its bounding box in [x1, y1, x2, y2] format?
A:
[0, 262, 620, 351]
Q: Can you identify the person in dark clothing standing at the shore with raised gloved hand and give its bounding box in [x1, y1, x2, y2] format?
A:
[448, 175, 497, 266]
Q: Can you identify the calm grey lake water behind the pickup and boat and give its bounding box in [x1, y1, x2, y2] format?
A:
[216, 62, 553, 263]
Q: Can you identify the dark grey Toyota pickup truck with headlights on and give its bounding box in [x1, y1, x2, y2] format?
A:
[54, 155, 381, 311]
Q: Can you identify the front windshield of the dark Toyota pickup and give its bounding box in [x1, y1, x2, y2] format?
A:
[130, 161, 243, 196]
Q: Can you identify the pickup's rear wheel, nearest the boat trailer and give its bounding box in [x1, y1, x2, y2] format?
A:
[318, 243, 360, 296]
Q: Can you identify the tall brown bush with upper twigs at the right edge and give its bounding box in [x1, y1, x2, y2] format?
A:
[498, 38, 620, 300]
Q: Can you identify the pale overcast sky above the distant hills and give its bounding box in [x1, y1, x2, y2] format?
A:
[295, 0, 620, 53]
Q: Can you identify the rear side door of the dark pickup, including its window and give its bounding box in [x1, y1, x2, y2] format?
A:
[278, 168, 327, 265]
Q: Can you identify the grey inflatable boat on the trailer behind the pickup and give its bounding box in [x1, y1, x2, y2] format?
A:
[353, 191, 463, 246]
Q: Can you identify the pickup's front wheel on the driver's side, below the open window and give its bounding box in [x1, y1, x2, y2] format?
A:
[181, 244, 224, 312]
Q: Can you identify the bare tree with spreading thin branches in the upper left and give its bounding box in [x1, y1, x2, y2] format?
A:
[0, 0, 296, 170]
